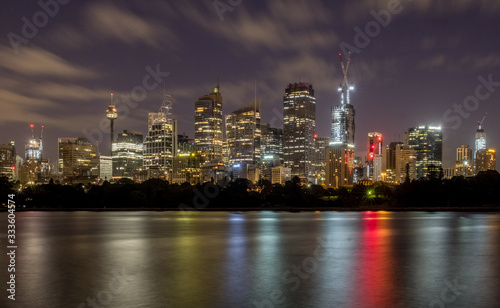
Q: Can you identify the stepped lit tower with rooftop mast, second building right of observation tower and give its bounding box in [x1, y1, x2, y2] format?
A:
[143, 94, 177, 181]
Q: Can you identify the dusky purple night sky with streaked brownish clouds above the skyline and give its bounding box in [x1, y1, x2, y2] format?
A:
[0, 0, 500, 167]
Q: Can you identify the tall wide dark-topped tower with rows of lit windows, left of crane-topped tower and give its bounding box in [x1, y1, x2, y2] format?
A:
[283, 82, 316, 183]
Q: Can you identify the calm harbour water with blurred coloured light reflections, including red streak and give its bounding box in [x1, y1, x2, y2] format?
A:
[0, 212, 500, 308]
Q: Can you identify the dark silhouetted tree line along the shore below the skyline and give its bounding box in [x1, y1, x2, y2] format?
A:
[0, 171, 500, 209]
